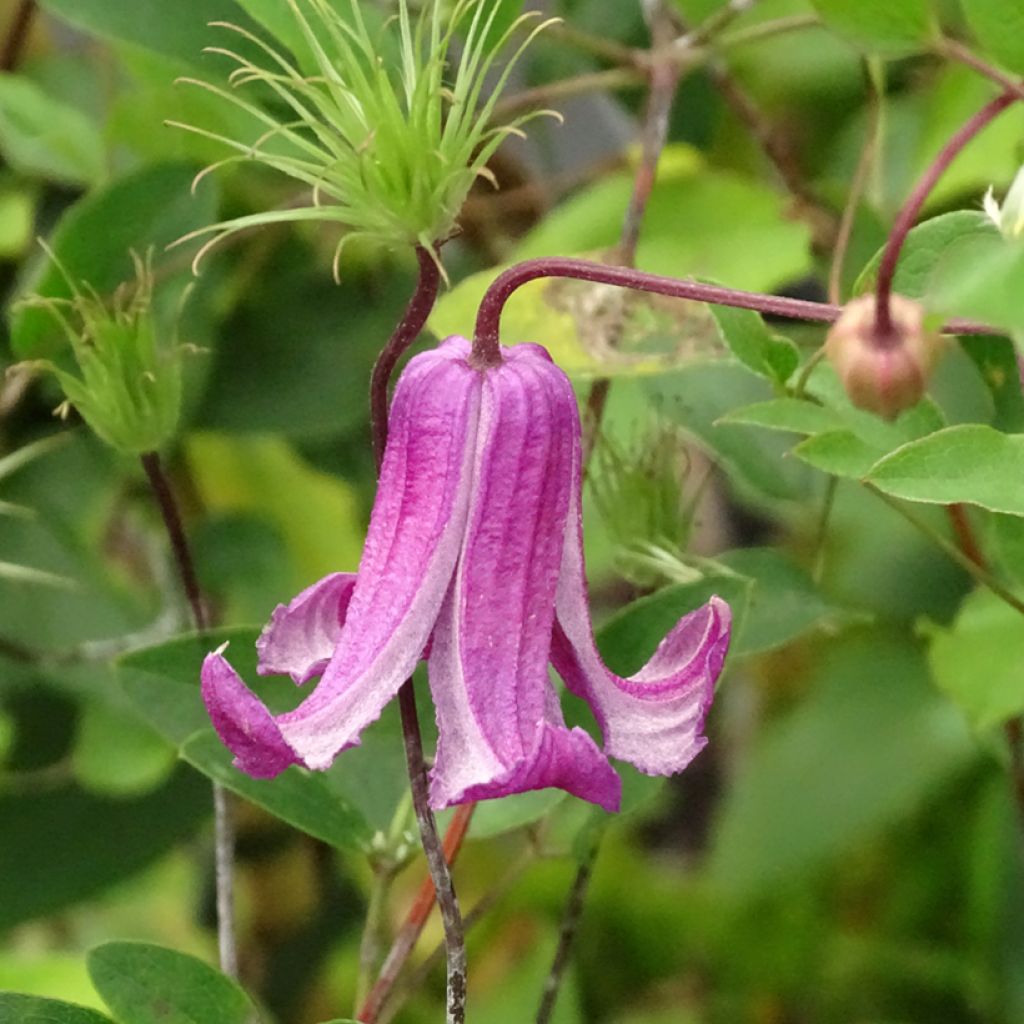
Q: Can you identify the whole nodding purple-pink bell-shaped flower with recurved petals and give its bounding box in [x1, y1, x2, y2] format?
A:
[203, 338, 730, 811]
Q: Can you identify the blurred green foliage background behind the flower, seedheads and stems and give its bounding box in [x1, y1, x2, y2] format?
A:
[0, 0, 1024, 1024]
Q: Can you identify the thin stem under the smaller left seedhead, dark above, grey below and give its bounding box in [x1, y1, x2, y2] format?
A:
[140, 452, 239, 978]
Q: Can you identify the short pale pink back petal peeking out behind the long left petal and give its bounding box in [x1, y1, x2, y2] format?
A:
[256, 572, 356, 686]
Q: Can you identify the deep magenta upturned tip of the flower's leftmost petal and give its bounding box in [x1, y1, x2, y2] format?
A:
[202, 647, 301, 778]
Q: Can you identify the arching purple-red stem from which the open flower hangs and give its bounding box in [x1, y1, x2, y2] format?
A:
[471, 256, 1000, 368]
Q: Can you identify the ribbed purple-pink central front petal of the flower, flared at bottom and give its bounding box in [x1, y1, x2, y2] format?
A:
[429, 346, 621, 810]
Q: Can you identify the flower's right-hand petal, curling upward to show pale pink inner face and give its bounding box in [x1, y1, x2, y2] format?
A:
[551, 407, 731, 775]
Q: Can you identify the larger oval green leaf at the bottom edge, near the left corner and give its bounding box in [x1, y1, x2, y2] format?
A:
[86, 942, 255, 1024]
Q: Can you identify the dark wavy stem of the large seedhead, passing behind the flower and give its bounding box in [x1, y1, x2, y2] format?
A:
[370, 246, 466, 1024]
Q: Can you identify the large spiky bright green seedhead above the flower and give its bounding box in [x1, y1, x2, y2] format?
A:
[175, 0, 550, 276]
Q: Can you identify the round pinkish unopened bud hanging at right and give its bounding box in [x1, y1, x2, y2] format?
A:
[825, 295, 942, 420]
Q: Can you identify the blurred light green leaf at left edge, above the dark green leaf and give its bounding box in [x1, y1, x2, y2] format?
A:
[0, 75, 105, 185]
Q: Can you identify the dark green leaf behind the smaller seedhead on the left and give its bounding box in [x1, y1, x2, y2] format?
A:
[11, 164, 216, 358]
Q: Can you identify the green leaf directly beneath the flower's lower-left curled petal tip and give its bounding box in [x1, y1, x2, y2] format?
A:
[181, 729, 372, 850]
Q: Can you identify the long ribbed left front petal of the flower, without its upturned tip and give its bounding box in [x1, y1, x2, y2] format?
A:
[276, 339, 481, 769]
